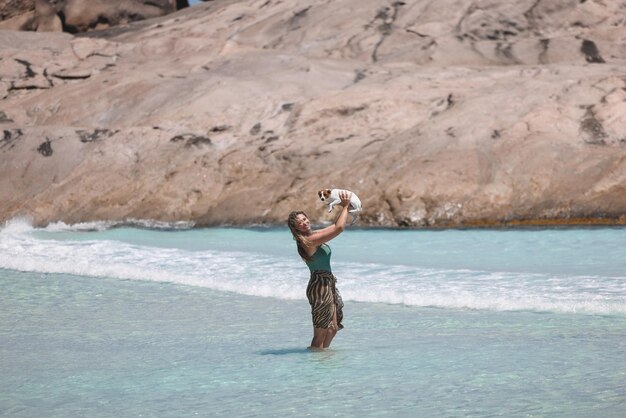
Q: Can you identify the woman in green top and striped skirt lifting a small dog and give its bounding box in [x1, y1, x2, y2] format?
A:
[287, 192, 351, 349]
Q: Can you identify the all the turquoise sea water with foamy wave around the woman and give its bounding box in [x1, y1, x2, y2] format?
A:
[0, 220, 626, 417]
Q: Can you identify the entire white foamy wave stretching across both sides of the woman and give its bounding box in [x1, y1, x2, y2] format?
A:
[0, 220, 626, 315]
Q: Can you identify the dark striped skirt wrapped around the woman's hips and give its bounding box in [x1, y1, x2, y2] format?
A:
[306, 270, 343, 329]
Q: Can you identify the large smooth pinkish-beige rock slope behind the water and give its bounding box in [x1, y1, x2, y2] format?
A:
[0, 0, 626, 227]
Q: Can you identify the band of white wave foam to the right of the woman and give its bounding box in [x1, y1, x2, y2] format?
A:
[336, 264, 626, 315]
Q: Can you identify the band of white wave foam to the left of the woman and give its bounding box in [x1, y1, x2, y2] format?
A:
[0, 220, 306, 299]
